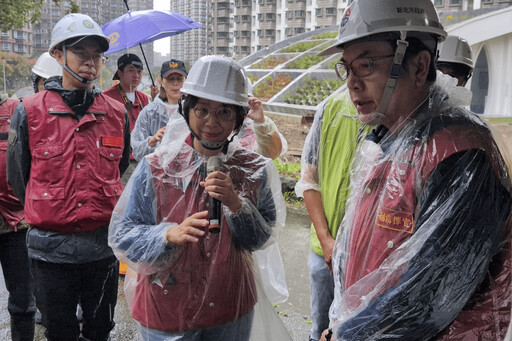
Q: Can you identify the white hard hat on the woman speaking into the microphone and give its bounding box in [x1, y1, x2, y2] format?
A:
[181, 56, 249, 107]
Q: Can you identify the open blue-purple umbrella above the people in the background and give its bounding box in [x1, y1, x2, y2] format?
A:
[101, 10, 203, 54]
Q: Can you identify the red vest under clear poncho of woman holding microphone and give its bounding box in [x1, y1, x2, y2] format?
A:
[131, 145, 261, 332]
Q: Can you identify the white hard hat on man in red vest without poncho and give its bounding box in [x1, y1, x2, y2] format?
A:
[48, 13, 110, 55]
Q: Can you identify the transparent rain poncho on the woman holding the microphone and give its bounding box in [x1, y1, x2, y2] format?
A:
[109, 115, 290, 340]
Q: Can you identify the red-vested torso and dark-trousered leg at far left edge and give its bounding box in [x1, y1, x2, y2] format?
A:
[0, 94, 36, 341]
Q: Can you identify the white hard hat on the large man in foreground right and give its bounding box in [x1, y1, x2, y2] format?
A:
[319, 0, 447, 56]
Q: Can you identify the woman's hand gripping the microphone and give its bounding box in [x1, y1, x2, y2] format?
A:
[201, 171, 242, 212]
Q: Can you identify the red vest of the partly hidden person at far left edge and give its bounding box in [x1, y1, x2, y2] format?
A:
[0, 99, 23, 230]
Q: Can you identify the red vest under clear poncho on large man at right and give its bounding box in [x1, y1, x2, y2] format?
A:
[344, 126, 512, 341]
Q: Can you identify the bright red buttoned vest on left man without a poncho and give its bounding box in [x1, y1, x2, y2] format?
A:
[23, 91, 125, 232]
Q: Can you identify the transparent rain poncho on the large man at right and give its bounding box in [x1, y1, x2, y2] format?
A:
[330, 73, 512, 341]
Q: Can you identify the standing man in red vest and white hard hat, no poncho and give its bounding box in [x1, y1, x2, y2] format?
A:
[7, 13, 130, 341]
